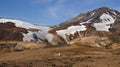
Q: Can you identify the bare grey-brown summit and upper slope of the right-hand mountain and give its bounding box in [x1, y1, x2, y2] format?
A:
[60, 7, 120, 27]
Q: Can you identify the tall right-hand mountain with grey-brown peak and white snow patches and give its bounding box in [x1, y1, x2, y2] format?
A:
[49, 7, 120, 47]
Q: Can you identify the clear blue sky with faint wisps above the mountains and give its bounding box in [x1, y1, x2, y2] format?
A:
[0, 0, 120, 26]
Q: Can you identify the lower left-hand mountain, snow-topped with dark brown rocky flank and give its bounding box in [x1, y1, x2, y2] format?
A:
[0, 18, 50, 41]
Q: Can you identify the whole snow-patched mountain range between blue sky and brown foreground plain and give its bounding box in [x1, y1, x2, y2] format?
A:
[0, 7, 120, 47]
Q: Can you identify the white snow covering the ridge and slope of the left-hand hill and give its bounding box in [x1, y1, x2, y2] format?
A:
[0, 18, 53, 41]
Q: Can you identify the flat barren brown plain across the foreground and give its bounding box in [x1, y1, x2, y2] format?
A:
[0, 45, 120, 67]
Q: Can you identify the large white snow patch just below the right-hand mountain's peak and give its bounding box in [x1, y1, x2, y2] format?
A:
[93, 13, 115, 32]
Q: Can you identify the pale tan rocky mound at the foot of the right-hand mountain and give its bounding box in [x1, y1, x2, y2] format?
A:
[68, 36, 112, 47]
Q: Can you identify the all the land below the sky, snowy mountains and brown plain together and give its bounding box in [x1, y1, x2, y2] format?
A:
[0, 7, 120, 67]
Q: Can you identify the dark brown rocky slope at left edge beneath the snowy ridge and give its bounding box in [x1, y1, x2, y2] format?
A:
[0, 22, 27, 41]
